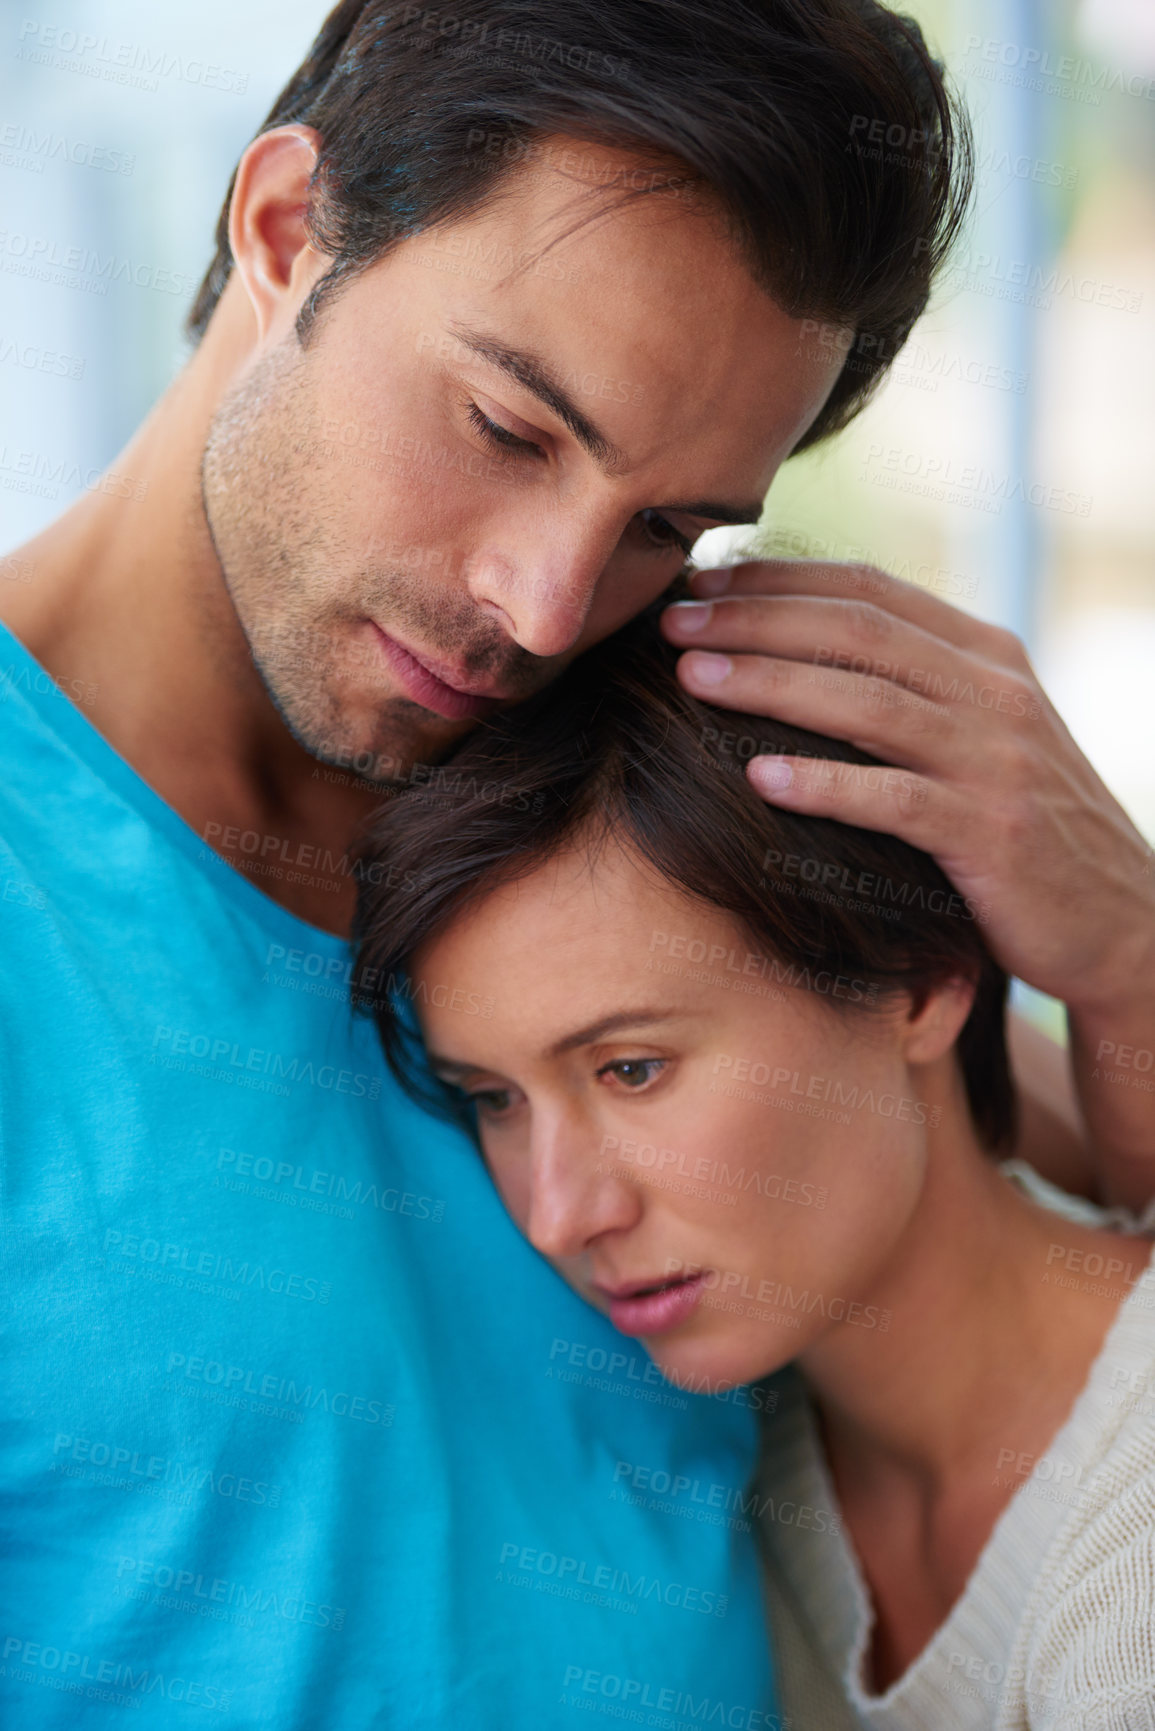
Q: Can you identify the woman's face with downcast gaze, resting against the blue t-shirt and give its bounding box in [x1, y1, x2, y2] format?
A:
[412, 843, 955, 1388]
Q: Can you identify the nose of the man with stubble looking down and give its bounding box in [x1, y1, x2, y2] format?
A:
[468, 516, 622, 656]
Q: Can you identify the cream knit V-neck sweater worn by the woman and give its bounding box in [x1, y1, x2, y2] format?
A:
[757, 1222, 1155, 1731]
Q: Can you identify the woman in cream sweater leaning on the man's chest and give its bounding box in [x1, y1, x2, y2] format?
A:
[358, 621, 1155, 1731]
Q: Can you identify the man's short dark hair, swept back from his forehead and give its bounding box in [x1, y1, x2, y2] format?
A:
[189, 0, 973, 450]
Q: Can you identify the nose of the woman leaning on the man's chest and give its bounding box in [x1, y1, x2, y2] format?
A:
[525, 1125, 642, 1257]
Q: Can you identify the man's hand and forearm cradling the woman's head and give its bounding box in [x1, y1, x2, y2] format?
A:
[663, 559, 1155, 1205]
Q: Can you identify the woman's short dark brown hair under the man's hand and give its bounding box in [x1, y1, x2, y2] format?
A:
[355, 608, 1015, 1148]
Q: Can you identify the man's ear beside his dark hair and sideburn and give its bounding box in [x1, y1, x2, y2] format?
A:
[229, 126, 329, 343]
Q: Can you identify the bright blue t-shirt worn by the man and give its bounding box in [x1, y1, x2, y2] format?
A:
[0, 628, 778, 1731]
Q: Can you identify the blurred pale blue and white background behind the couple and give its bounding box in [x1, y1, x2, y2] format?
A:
[0, 0, 1155, 1021]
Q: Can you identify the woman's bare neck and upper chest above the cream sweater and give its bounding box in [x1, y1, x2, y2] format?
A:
[800, 1059, 1146, 1688]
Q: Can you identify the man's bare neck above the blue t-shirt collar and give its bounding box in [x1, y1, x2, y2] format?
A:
[0, 309, 381, 933]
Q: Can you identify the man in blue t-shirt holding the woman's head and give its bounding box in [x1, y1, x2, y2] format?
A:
[0, 0, 1152, 1731]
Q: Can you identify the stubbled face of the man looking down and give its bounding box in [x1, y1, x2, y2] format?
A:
[204, 140, 838, 779]
